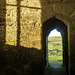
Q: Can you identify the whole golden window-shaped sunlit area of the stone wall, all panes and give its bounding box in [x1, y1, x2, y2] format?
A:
[6, 0, 42, 49]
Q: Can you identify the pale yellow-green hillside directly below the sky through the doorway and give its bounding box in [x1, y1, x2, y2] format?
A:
[48, 36, 62, 50]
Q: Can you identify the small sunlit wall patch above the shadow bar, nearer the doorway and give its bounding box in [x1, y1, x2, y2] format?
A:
[21, 0, 41, 8]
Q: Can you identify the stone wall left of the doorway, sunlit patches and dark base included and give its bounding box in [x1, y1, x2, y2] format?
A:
[0, 0, 43, 75]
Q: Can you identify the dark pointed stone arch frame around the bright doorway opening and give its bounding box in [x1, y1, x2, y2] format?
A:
[42, 17, 68, 74]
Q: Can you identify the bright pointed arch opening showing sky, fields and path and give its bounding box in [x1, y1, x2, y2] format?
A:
[47, 29, 63, 68]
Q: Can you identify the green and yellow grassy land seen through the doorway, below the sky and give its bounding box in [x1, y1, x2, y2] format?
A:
[48, 36, 63, 61]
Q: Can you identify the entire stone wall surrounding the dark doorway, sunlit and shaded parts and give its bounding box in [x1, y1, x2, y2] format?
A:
[0, 0, 75, 75]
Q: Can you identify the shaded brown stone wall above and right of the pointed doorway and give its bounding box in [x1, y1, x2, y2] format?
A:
[41, 0, 75, 74]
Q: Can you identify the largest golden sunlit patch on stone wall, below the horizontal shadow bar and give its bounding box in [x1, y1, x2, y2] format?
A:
[20, 7, 42, 49]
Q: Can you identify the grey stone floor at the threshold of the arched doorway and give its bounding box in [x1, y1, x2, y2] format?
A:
[44, 61, 66, 75]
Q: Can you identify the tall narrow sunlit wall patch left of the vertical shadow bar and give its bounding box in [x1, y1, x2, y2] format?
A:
[6, 6, 17, 46]
